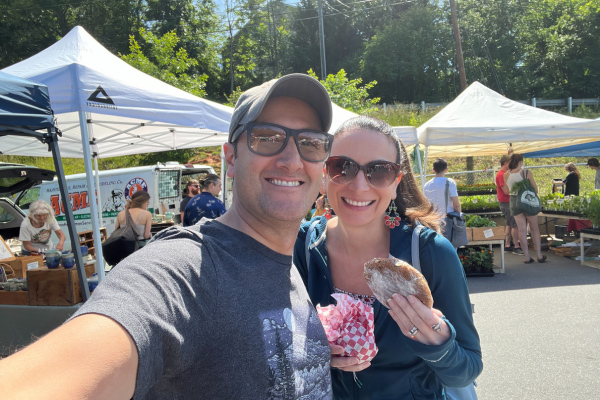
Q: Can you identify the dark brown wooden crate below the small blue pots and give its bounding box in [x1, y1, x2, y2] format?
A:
[27, 264, 94, 306]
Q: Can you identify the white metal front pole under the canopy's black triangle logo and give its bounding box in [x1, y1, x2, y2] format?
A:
[76, 111, 104, 282]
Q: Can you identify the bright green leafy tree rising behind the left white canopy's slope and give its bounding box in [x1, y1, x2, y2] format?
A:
[121, 28, 207, 97]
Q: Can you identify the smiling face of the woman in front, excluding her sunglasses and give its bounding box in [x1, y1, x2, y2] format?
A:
[325, 129, 400, 227]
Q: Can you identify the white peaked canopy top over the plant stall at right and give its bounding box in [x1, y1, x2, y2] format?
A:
[417, 82, 600, 162]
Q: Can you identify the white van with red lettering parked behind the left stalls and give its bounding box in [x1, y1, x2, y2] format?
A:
[15, 161, 215, 248]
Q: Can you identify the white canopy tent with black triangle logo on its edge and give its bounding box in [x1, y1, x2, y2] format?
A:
[0, 26, 233, 276]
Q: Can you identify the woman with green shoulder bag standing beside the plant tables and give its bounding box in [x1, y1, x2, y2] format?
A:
[504, 153, 546, 264]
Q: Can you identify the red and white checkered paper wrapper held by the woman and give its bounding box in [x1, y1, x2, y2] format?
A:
[317, 293, 378, 364]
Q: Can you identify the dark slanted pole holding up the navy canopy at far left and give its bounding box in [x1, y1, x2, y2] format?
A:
[48, 128, 90, 301]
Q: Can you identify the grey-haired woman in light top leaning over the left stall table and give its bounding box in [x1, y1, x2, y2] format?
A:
[19, 200, 66, 253]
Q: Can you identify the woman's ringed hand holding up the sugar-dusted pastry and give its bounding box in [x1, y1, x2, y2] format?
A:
[390, 294, 450, 346]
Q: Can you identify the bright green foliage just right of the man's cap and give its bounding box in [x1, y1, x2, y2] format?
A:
[308, 69, 379, 114]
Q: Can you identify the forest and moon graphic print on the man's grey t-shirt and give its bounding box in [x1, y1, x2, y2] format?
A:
[260, 303, 331, 400]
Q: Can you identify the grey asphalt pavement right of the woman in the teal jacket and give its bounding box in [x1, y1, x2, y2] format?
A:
[467, 248, 600, 400]
